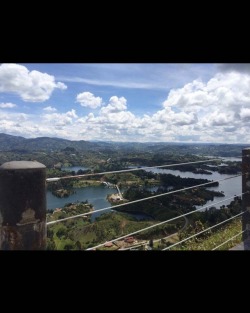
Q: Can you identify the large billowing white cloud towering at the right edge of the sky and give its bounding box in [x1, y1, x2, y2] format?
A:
[152, 71, 250, 142]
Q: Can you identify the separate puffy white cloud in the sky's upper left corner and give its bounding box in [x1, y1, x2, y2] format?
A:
[0, 64, 67, 102]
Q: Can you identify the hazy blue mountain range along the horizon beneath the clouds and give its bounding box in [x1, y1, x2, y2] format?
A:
[0, 133, 246, 156]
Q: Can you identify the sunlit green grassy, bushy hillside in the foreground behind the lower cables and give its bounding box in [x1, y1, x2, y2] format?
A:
[47, 197, 241, 251]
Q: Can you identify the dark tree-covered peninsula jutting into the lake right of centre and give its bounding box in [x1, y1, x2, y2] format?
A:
[117, 171, 224, 221]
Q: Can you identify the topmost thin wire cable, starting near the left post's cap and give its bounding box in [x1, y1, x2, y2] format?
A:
[46, 158, 221, 183]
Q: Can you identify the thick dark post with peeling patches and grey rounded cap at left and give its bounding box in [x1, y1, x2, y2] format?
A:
[0, 161, 47, 250]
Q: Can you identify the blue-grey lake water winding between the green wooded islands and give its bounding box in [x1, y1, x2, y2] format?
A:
[47, 158, 242, 221]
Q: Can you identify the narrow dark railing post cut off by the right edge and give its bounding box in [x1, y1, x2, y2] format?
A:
[242, 148, 250, 250]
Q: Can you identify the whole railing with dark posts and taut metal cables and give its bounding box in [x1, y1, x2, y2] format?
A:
[0, 148, 250, 250]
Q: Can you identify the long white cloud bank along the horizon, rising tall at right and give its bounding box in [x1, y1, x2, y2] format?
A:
[3, 71, 250, 143]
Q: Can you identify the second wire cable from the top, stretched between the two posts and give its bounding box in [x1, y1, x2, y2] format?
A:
[47, 174, 242, 225]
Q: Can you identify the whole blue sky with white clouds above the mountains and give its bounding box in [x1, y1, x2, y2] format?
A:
[0, 63, 250, 144]
